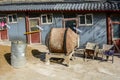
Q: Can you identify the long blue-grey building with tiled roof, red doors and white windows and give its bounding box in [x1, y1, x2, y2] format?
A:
[0, 0, 120, 47]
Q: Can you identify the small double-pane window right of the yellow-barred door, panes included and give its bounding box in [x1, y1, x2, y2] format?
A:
[41, 14, 53, 24]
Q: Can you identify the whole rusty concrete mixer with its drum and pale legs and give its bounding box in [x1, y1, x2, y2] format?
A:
[46, 28, 79, 65]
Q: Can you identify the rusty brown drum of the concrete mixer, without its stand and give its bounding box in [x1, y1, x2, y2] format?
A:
[46, 28, 78, 54]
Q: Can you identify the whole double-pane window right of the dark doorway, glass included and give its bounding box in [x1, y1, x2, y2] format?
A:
[79, 14, 93, 25]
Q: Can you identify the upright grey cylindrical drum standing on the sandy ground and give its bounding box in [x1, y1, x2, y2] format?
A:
[11, 41, 26, 68]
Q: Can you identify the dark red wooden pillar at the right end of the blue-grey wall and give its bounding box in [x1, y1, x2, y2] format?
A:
[106, 14, 112, 44]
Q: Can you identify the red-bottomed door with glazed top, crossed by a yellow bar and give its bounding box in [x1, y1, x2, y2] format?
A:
[29, 18, 40, 43]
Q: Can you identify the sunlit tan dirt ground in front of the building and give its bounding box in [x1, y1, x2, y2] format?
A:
[0, 44, 120, 80]
